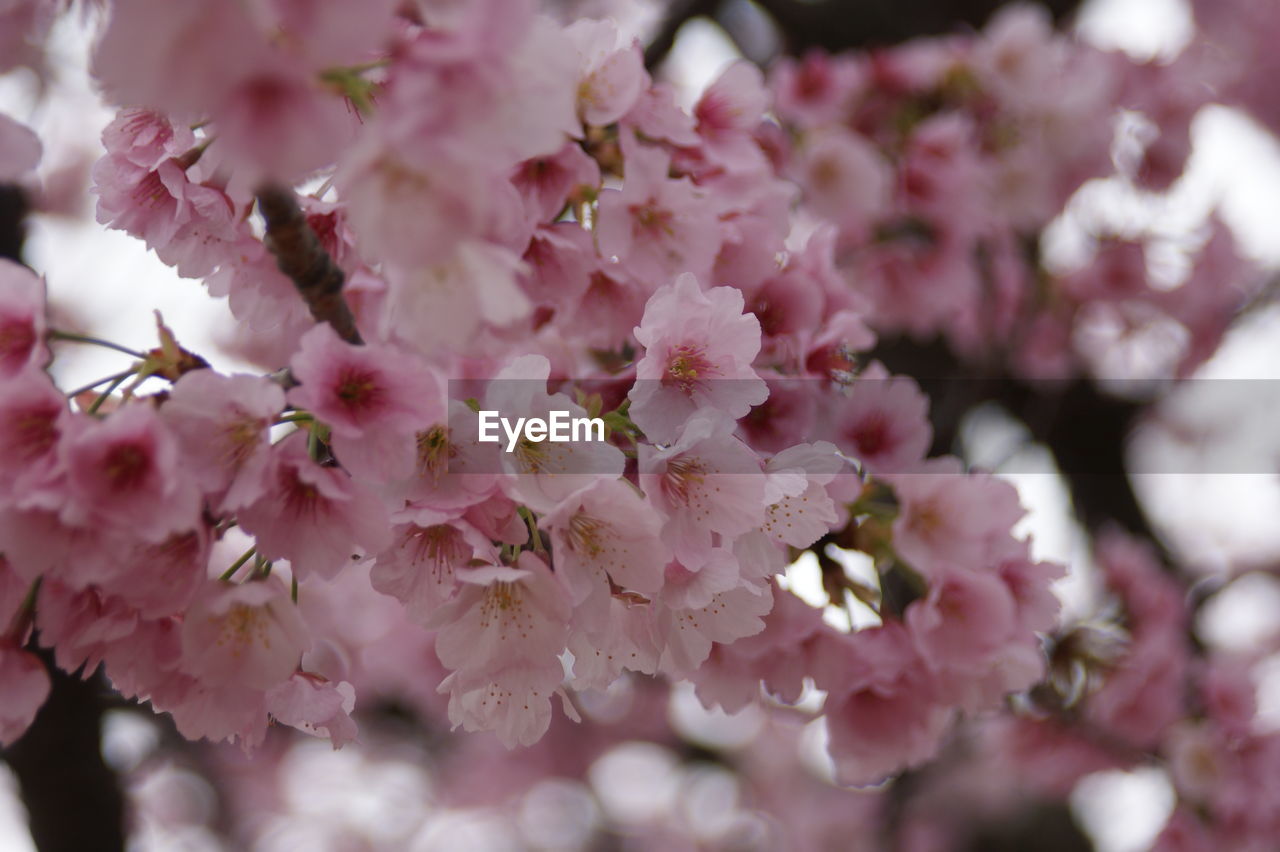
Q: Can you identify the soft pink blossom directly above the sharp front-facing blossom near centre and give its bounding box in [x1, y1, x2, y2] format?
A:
[595, 141, 721, 287]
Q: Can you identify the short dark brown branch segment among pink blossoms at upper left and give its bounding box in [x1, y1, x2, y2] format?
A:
[257, 184, 364, 345]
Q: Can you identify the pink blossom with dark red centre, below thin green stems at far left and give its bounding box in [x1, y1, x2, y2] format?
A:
[60, 404, 200, 541]
